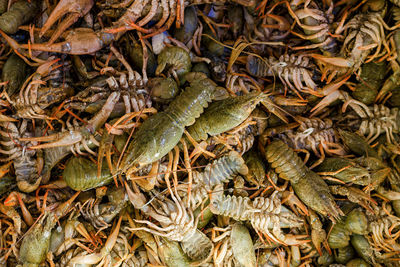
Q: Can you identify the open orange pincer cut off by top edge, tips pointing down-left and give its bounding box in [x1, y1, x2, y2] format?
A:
[39, 0, 94, 44]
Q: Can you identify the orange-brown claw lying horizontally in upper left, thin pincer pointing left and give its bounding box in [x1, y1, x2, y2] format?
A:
[20, 28, 114, 55]
